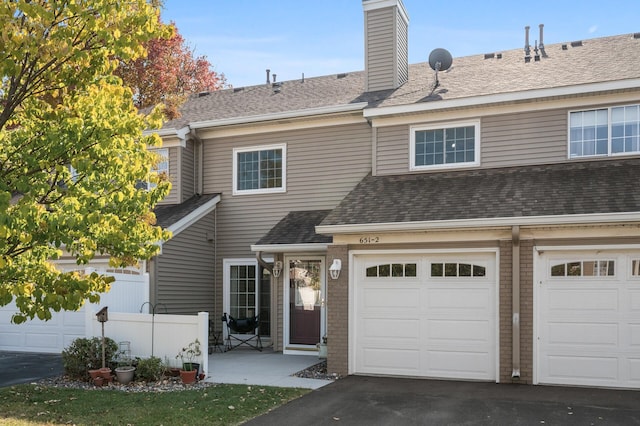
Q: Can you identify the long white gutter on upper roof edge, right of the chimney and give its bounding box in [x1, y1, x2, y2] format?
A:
[364, 78, 640, 118]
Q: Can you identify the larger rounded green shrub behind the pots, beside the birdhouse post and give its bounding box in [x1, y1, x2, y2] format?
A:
[62, 337, 118, 380]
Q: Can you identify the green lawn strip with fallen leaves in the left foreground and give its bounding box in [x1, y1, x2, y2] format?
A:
[0, 384, 309, 426]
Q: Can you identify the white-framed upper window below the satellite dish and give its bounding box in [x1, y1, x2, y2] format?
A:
[410, 121, 480, 170]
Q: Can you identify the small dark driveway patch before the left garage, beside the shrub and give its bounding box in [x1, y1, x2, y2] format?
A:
[0, 351, 63, 388]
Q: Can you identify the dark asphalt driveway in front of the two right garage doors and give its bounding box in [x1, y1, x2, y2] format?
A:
[247, 376, 640, 426]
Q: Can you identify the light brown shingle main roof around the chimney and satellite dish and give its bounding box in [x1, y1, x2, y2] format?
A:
[164, 34, 640, 129]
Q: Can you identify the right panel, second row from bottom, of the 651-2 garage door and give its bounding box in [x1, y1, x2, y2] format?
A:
[427, 319, 492, 344]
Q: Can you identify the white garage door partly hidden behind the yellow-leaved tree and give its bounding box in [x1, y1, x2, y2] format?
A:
[0, 271, 149, 353]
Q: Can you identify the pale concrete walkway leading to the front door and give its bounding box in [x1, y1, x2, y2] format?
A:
[205, 348, 332, 389]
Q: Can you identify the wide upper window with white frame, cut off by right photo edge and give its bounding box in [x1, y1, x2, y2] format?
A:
[569, 105, 640, 158]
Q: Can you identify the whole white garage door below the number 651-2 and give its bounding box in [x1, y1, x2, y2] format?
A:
[353, 252, 497, 381]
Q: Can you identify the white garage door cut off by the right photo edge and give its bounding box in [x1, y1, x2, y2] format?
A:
[536, 250, 640, 388]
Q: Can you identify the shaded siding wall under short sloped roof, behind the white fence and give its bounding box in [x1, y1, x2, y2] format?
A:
[153, 212, 216, 314]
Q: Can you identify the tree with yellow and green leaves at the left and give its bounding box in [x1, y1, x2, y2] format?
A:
[0, 0, 171, 323]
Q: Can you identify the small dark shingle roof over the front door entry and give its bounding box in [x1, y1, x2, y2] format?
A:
[256, 210, 333, 245]
